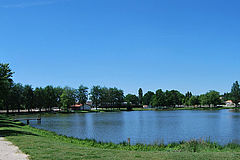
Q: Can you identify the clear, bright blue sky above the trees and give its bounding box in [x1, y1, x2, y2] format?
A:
[0, 0, 240, 94]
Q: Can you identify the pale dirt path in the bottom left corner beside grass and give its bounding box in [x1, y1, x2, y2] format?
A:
[0, 137, 28, 160]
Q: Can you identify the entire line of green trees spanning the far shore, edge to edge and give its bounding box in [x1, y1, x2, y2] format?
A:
[0, 63, 240, 112]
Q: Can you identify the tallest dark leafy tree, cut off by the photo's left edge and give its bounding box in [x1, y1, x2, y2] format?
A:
[0, 63, 14, 113]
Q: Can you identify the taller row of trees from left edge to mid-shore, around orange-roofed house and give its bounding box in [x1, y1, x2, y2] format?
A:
[0, 64, 124, 112]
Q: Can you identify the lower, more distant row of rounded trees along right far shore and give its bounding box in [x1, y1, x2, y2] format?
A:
[126, 81, 240, 107]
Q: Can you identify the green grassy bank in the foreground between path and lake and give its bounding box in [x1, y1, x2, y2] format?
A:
[0, 115, 240, 160]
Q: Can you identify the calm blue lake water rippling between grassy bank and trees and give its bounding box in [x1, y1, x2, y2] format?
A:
[16, 110, 240, 144]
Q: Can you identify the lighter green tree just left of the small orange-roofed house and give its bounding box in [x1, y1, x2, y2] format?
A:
[60, 87, 76, 112]
